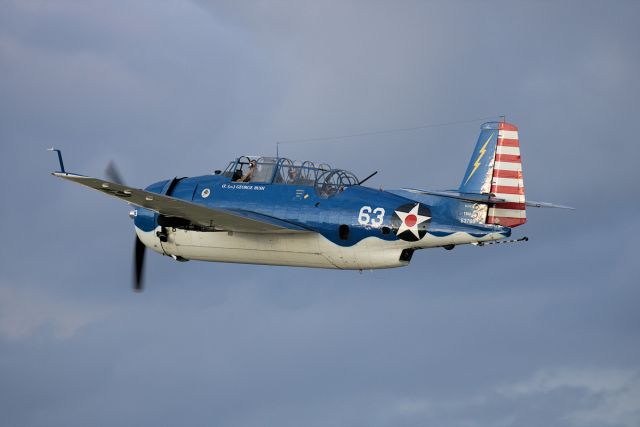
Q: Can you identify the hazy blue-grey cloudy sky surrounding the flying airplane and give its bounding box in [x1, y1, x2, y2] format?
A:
[0, 0, 640, 427]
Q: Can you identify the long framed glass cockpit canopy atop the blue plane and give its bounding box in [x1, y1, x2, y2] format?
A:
[222, 156, 360, 198]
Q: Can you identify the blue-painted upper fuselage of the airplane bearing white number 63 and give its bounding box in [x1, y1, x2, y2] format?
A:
[135, 175, 510, 248]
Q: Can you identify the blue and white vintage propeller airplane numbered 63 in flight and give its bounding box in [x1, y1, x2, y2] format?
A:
[49, 121, 573, 291]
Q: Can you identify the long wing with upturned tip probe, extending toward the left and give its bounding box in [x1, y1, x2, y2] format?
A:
[52, 172, 311, 233]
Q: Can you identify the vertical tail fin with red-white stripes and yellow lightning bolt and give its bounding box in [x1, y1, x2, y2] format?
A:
[459, 122, 527, 227]
